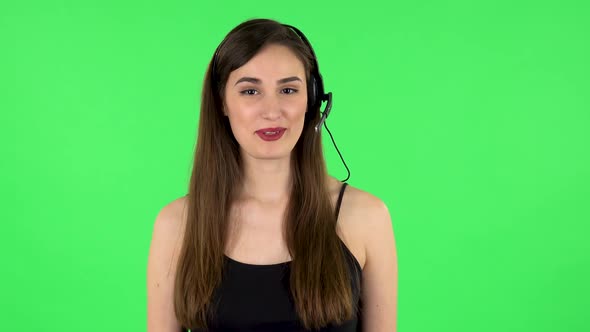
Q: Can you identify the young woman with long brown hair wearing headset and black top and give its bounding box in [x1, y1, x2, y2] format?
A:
[147, 19, 397, 332]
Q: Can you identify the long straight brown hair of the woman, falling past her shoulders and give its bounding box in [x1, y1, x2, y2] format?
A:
[174, 19, 357, 329]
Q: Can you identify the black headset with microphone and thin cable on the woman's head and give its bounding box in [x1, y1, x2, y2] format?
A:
[211, 24, 350, 182]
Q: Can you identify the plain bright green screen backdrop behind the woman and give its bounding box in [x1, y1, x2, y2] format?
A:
[0, 0, 590, 332]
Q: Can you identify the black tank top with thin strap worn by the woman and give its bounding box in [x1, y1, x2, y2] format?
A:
[183, 183, 362, 332]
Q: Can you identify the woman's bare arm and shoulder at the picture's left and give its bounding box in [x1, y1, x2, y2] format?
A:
[147, 198, 183, 332]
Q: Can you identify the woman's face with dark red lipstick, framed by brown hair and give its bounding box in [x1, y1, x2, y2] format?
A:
[224, 45, 307, 163]
